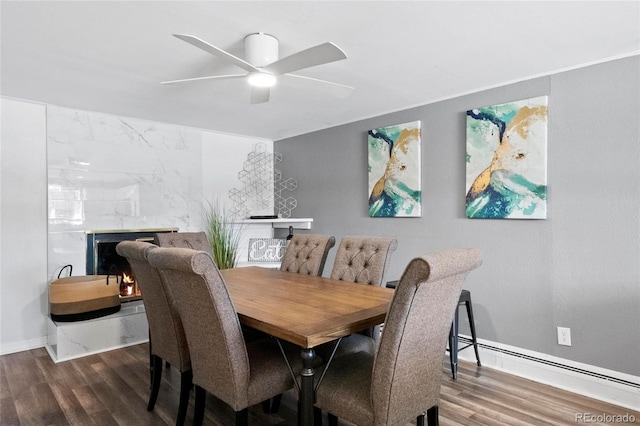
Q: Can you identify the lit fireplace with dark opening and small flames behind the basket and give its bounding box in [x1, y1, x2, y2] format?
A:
[86, 228, 178, 302]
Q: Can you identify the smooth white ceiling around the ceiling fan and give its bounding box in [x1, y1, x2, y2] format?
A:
[0, 1, 640, 140]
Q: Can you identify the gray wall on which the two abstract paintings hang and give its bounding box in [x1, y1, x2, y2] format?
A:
[274, 56, 640, 376]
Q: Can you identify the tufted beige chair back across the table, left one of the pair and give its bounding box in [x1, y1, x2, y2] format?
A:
[280, 234, 336, 276]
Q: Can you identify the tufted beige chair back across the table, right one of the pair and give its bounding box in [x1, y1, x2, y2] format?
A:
[331, 236, 398, 286]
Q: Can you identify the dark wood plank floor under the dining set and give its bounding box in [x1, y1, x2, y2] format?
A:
[0, 344, 640, 426]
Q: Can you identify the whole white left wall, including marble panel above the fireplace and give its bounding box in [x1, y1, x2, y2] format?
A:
[0, 98, 273, 354]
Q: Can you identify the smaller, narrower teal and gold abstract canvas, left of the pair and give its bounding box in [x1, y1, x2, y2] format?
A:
[367, 121, 422, 217]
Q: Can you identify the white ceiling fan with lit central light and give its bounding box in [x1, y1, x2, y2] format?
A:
[161, 33, 353, 104]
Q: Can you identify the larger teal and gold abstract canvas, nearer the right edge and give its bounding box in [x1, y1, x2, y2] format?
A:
[466, 96, 547, 219]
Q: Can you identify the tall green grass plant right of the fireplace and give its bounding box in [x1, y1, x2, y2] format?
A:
[205, 202, 241, 269]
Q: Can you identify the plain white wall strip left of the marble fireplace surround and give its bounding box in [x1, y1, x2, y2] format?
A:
[0, 99, 48, 353]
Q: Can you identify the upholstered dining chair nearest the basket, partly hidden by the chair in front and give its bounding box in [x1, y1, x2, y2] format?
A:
[116, 241, 193, 425]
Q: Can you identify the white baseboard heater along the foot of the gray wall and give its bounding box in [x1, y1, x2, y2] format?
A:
[458, 335, 640, 411]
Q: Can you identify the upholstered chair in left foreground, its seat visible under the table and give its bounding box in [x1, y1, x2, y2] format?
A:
[149, 247, 301, 425]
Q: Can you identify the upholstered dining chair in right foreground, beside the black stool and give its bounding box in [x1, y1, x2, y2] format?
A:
[316, 249, 482, 426]
